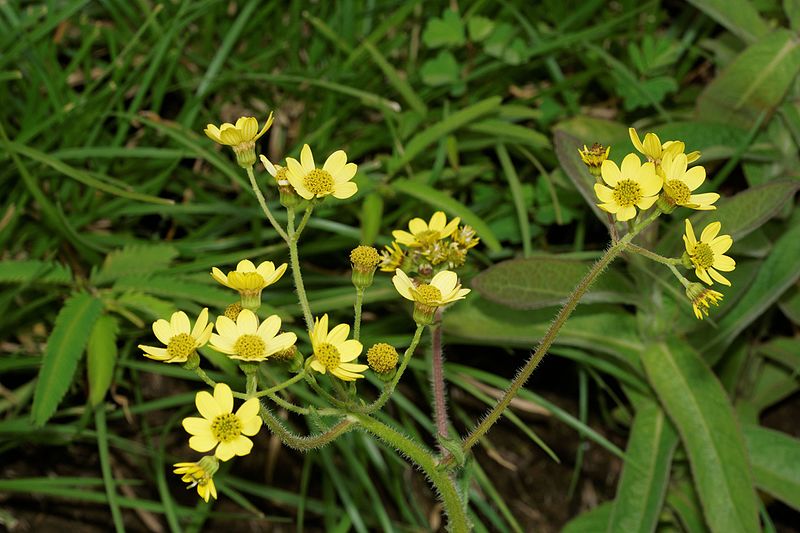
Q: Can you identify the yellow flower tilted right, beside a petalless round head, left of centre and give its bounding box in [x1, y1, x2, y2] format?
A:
[308, 314, 369, 381]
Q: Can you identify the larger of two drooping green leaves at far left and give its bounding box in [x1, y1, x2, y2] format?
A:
[31, 292, 103, 426]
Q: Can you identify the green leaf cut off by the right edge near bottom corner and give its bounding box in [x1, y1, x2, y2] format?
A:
[742, 425, 800, 511]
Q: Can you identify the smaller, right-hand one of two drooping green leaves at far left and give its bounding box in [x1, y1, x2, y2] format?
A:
[86, 315, 119, 407]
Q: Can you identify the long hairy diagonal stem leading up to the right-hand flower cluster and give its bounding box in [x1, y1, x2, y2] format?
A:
[456, 209, 661, 465]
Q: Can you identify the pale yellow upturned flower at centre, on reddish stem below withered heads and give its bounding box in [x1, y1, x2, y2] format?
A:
[392, 268, 470, 325]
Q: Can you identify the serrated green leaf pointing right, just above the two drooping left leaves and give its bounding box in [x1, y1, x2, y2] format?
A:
[92, 244, 178, 285]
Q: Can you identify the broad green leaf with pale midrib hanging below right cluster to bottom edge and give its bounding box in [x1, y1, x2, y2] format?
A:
[641, 340, 759, 533]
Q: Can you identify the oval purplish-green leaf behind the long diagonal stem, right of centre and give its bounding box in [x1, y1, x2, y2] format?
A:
[472, 255, 638, 309]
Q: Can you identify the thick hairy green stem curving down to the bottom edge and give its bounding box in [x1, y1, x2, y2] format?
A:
[352, 414, 470, 533]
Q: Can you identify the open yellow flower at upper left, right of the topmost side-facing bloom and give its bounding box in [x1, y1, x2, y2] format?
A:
[286, 144, 358, 200]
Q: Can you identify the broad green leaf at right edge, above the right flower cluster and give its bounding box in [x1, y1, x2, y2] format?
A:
[697, 29, 800, 130]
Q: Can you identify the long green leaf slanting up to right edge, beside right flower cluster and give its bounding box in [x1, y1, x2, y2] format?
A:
[703, 216, 800, 358]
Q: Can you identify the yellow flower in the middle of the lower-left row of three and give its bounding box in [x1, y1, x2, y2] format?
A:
[211, 309, 297, 361]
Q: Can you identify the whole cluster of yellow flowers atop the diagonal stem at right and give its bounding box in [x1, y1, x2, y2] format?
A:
[579, 128, 736, 319]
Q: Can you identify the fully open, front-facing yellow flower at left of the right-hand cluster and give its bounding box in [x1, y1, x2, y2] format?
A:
[594, 154, 661, 221]
